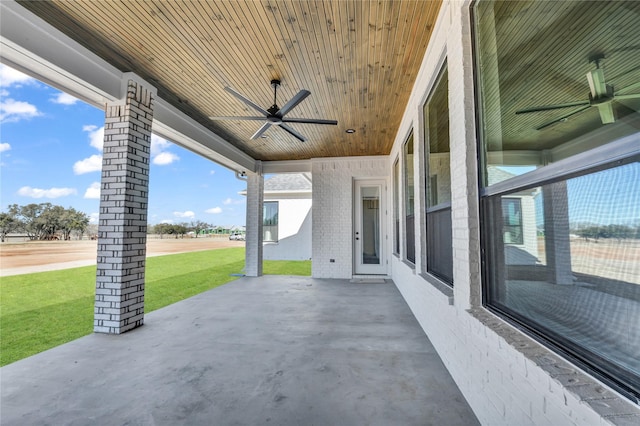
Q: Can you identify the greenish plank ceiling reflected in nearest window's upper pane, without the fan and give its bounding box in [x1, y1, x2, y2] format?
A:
[476, 0, 640, 151]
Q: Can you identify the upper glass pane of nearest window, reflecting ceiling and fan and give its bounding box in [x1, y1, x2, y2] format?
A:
[474, 0, 640, 185]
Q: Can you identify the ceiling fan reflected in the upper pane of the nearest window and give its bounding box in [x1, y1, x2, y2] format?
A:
[516, 55, 640, 130]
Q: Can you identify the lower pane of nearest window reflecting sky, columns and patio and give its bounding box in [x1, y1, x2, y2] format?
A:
[488, 162, 640, 386]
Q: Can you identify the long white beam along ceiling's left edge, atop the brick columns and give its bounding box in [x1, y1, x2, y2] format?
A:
[0, 1, 256, 172]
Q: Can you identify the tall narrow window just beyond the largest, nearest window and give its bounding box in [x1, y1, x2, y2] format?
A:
[424, 65, 453, 284]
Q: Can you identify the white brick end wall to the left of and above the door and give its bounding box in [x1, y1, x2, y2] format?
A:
[311, 157, 391, 278]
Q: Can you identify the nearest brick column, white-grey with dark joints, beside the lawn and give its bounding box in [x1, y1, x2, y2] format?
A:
[93, 80, 155, 334]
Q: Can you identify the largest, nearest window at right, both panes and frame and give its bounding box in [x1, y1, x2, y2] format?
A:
[473, 0, 640, 398]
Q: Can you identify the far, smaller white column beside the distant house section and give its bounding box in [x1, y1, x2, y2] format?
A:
[245, 164, 264, 277]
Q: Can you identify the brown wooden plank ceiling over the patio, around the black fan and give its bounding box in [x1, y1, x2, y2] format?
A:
[21, 0, 441, 160]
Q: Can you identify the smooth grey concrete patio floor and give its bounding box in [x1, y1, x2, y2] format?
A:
[0, 276, 478, 426]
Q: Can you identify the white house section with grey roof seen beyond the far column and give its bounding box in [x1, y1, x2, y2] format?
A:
[241, 173, 311, 260]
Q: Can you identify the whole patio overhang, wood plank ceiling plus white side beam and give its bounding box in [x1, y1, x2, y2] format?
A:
[1, 0, 441, 172]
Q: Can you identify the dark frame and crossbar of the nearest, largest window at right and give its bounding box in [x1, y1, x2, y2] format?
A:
[470, 1, 640, 404]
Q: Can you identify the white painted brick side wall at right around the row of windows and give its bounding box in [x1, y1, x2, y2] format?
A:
[382, 1, 640, 426]
